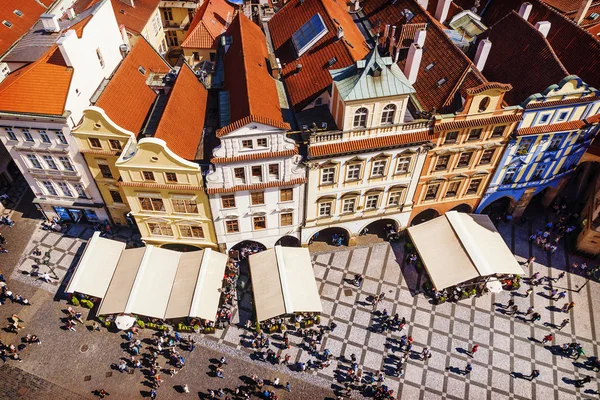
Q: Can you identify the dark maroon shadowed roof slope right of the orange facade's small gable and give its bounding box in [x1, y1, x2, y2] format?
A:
[484, 11, 569, 105]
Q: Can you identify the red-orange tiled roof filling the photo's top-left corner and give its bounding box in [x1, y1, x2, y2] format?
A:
[0, 0, 52, 55]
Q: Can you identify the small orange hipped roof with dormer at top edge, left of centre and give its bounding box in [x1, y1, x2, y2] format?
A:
[181, 0, 235, 49]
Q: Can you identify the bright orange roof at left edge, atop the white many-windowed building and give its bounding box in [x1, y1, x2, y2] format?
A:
[0, 45, 73, 115]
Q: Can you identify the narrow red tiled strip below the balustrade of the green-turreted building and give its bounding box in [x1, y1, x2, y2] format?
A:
[308, 130, 433, 158]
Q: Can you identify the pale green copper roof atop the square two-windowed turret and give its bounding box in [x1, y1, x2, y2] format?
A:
[329, 47, 415, 101]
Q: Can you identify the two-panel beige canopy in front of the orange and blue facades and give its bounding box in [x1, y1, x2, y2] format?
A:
[408, 211, 523, 290]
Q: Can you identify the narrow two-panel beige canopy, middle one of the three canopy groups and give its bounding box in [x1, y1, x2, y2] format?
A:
[249, 246, 323, 322]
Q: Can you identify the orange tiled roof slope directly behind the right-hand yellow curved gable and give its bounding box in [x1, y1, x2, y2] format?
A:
[154, 63, 208, 160]
